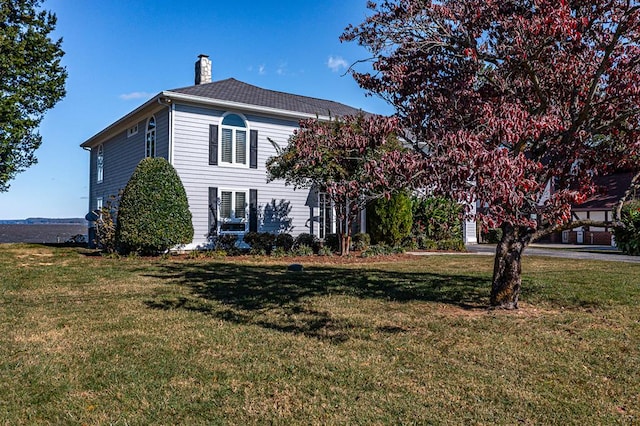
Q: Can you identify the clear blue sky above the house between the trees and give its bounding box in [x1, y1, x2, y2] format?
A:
[0, 0, 392, 219]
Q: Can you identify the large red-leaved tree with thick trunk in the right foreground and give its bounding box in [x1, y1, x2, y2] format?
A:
[341, 0, 640, 309]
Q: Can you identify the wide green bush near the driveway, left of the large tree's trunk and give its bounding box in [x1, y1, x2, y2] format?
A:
[412, 197, 463, 241]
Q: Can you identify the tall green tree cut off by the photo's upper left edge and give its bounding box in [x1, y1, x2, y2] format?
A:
[0, 0, 67, 192]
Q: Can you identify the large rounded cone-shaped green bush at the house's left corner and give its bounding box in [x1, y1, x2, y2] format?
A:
[115, 158, 193, 255]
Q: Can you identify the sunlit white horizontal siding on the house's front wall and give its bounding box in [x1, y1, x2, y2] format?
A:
[173, 105, 310, 246]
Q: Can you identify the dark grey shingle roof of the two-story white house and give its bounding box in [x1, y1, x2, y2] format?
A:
[169, 78, 362, 116]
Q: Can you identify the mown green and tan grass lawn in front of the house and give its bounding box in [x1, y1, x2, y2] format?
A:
[0, 244, 640, 425]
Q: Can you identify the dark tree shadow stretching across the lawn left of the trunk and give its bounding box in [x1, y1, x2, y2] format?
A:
[145, 263, 490, 342]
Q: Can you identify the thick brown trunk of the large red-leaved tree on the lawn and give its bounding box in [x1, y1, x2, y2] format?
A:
[491, 224, 530, 309]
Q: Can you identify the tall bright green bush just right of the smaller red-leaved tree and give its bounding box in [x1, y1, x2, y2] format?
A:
[367, 192, 413, 246]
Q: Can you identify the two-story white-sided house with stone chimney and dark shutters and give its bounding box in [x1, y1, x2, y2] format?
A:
[81, 55, 475, 249]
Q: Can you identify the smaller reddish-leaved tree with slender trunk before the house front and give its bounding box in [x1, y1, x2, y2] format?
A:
[267, 115, 423, 255]
